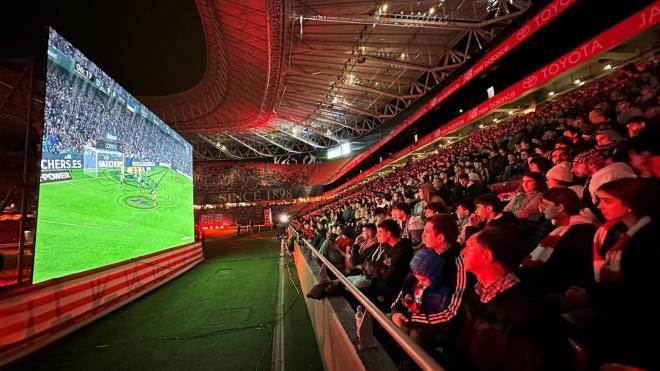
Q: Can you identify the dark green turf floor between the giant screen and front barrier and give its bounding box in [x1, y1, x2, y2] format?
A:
[9, 232, 323, 371]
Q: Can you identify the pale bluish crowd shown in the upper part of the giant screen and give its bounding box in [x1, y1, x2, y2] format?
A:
[42, 32, 192, 177]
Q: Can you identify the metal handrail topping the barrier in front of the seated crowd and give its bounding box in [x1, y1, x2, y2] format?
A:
[289, 226, 444, 371]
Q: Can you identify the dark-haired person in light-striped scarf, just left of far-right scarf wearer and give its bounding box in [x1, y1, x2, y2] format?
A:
[519, 187, 596, 294]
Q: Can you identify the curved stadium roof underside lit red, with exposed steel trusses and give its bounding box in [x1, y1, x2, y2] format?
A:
[143, 0, 531, 160]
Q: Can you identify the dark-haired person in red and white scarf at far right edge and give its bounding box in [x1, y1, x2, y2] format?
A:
[564, 178, 660, 369]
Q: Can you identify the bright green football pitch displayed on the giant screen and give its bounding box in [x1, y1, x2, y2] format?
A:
[33, 167, 194, 283]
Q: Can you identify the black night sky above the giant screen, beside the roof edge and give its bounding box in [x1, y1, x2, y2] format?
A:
[0, 0, 206, 96]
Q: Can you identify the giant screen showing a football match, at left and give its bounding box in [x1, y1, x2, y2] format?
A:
[33, 29, 194, 283]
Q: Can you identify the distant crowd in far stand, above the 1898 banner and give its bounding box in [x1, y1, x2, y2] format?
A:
[194, 165, 309, 193]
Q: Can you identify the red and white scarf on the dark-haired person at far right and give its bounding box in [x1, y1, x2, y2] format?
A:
[593, 216, 651, 284]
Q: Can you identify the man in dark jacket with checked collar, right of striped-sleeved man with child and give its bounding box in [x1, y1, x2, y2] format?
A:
[459, 227, 569, 370]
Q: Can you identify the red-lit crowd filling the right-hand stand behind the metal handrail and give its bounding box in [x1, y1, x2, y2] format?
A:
[294, 59, 660, 370]
